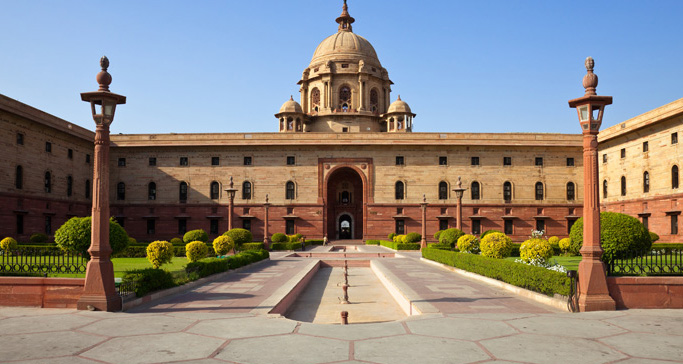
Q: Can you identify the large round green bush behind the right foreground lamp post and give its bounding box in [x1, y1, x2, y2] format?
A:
[569, 212, 652, 262]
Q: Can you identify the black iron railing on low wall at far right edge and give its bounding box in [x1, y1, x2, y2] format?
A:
[607, 248, 683, 276]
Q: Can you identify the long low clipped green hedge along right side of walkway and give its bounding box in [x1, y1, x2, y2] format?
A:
[422, 248, 571, 296]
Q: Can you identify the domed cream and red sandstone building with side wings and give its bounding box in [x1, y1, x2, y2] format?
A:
[0, 4, 683, 242]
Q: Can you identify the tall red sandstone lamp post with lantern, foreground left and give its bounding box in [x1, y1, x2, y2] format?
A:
[76, 57, 126, 311]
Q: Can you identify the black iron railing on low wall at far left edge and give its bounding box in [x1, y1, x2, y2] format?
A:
[0, 248, 88, 274]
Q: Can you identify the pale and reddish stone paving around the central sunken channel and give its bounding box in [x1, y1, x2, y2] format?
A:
[0, 247, 683, 364]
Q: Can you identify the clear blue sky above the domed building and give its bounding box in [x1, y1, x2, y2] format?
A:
[0, 0, 683, 133]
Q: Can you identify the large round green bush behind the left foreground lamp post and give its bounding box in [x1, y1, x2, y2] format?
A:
[55, 216, 128, 259]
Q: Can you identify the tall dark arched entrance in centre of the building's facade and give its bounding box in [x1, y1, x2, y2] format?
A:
[325, 167, 364, 239]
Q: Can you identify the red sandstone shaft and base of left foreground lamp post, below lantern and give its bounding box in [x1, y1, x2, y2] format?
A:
[76, 124, 122, 311]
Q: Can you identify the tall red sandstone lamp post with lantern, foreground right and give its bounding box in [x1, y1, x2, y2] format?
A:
[569, 57, 615, 311]
